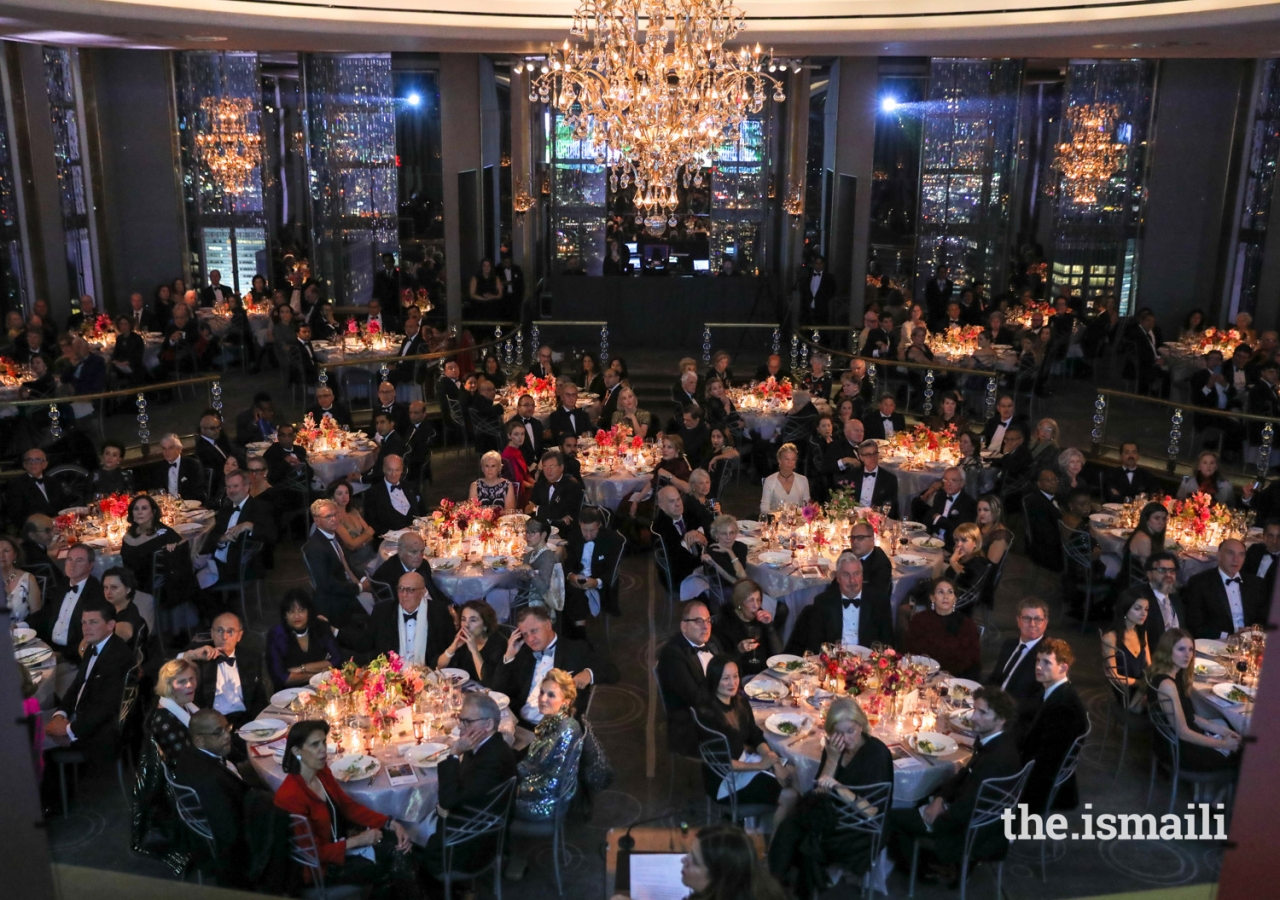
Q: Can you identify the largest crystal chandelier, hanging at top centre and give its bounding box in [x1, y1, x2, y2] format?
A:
[516, 0, 778, 229]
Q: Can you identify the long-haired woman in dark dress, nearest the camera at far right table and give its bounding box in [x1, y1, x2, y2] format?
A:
[1147, 629, 1240, 772]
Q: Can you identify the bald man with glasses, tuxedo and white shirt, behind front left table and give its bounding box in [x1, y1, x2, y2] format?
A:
[364, 572, 458, 668]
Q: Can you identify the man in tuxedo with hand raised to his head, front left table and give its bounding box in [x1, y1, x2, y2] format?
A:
[491, 604, 618, 730]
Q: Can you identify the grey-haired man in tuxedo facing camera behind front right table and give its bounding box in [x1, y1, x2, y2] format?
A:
[791, 550, 893, 653]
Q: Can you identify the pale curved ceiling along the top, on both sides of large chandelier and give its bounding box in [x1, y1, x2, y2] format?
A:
[0, 0, 1280, 59]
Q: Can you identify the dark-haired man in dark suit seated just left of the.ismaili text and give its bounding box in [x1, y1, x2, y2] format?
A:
[886, 687, 1023, 878]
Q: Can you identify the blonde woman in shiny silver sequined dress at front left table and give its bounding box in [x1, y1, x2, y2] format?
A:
[508, 668, 582, 824]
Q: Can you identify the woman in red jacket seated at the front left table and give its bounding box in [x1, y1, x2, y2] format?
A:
[275, 722, 409, 886]
